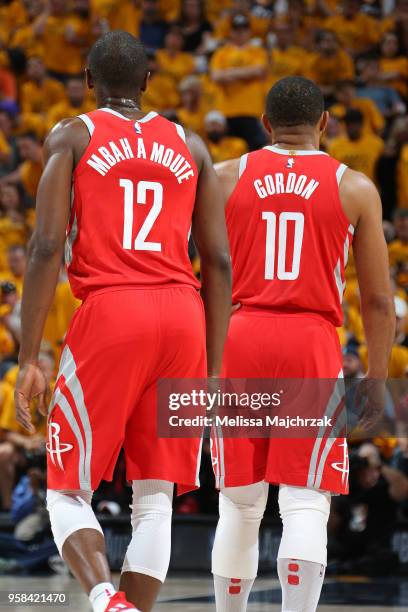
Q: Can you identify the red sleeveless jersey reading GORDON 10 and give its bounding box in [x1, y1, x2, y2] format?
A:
[227, 146, 354, 326]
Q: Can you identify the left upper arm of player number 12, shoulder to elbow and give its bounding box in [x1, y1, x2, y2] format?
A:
[33, 119, 83, 257]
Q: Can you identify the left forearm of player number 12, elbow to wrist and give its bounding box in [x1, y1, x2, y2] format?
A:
[19, 239, 63, 366]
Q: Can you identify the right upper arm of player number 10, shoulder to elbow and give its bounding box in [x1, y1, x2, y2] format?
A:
[340, 170, 391, 308]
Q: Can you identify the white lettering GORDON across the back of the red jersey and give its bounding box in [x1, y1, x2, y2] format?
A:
[254, 172, 319, 200]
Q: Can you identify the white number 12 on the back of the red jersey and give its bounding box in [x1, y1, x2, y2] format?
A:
[119, 179, 163, 251]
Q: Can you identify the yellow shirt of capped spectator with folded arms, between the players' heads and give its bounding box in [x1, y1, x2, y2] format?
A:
[210, 44, 268, 117]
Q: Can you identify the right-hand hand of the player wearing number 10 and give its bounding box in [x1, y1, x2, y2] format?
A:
[355, 375, 387, 432]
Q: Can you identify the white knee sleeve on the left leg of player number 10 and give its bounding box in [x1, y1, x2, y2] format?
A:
[212, 482, 269, 580]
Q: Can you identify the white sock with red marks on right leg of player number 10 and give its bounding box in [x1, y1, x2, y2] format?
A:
[278, 559, 326, 612]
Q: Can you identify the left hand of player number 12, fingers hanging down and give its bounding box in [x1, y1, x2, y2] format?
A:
[14, 363, 49, 433]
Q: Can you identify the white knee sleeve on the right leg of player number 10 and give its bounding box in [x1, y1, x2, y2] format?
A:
[278, 485, 331, 565]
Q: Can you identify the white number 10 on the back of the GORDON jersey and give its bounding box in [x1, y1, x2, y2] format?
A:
[262, 211, 305, 280]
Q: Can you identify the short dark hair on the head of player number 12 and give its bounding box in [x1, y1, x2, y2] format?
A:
[88, 30, 147, 95]
